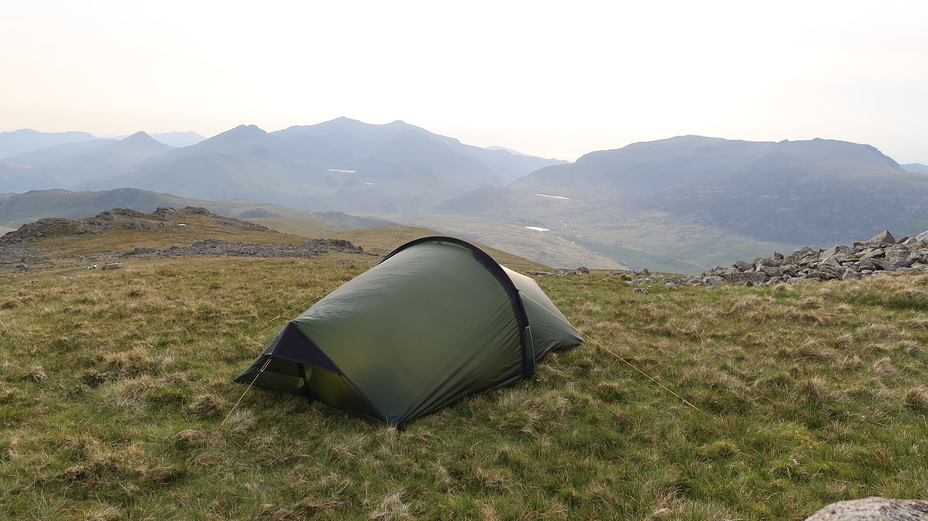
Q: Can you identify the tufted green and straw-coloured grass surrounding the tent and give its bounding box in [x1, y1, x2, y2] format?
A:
[0, 229, 928, 520]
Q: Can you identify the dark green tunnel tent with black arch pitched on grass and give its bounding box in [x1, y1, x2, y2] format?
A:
[235, 237, 581, 426]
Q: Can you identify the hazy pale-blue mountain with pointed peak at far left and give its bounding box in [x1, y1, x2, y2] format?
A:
[0, 132, 173, 192]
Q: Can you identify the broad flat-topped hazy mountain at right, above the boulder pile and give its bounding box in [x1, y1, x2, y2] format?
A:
[432, 136, 928, 273]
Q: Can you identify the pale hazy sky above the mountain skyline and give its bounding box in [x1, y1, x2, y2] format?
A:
[0, 0, 928, 163]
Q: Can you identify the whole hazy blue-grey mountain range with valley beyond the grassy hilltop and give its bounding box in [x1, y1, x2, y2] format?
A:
[0, 122, 928, 273]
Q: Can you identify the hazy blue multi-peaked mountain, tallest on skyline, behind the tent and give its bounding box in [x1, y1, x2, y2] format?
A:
[87, 118, 562, 214]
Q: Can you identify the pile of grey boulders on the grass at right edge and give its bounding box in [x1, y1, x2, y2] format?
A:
[701, 231, 928, 285]
